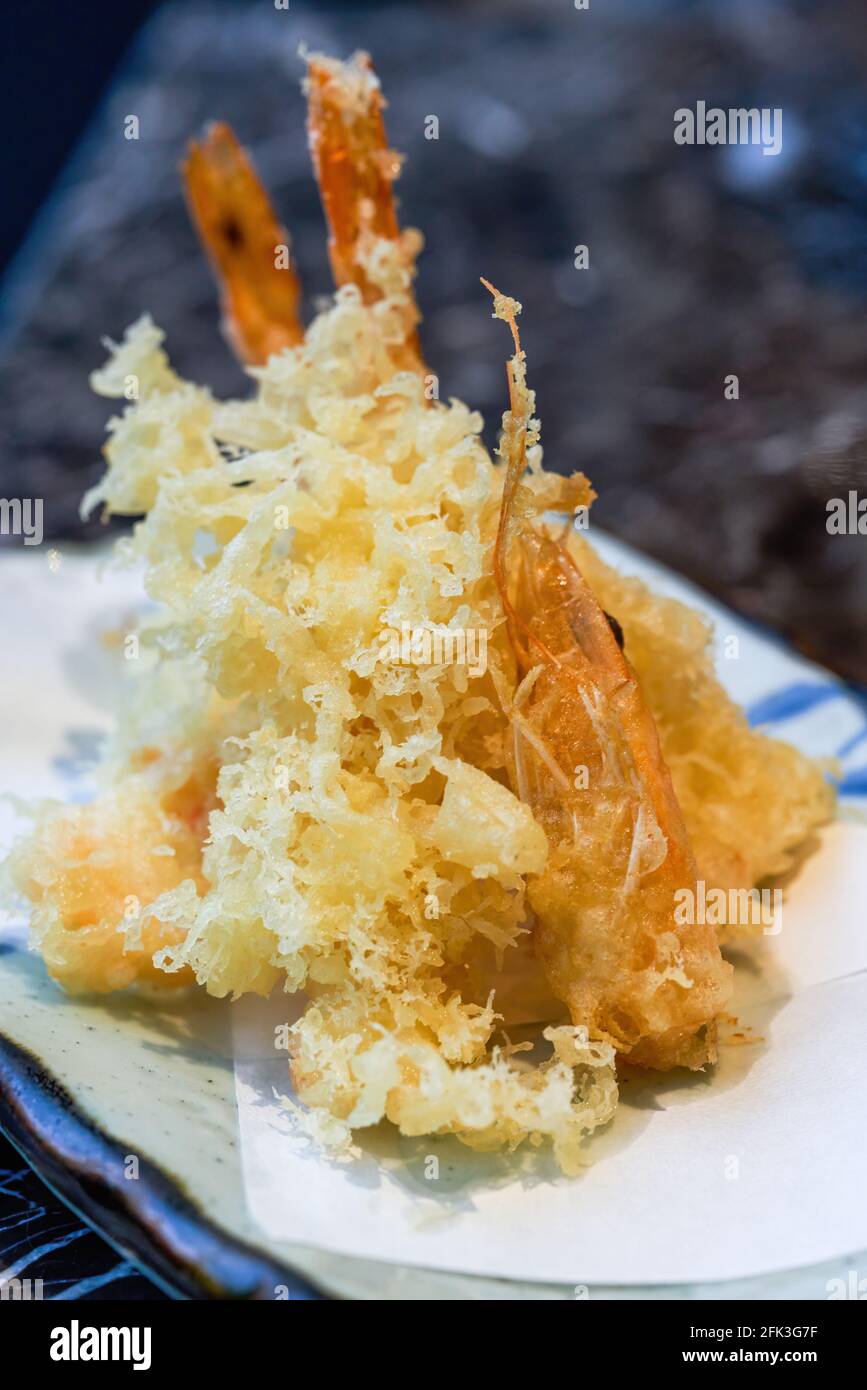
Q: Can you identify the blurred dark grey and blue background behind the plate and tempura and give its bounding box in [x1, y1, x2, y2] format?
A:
[0, 0, 867, 695]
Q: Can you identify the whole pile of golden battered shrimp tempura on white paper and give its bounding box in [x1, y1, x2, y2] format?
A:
[5, 56, 832, 1173]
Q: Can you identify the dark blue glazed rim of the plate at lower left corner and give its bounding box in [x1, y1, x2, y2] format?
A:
[0, 1034, 322, 1301]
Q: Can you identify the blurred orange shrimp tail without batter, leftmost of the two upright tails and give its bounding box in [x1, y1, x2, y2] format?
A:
[183, 122, 304, 366]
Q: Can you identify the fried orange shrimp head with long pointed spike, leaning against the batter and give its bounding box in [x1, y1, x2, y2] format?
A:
[486, 285, 732, 1069]
